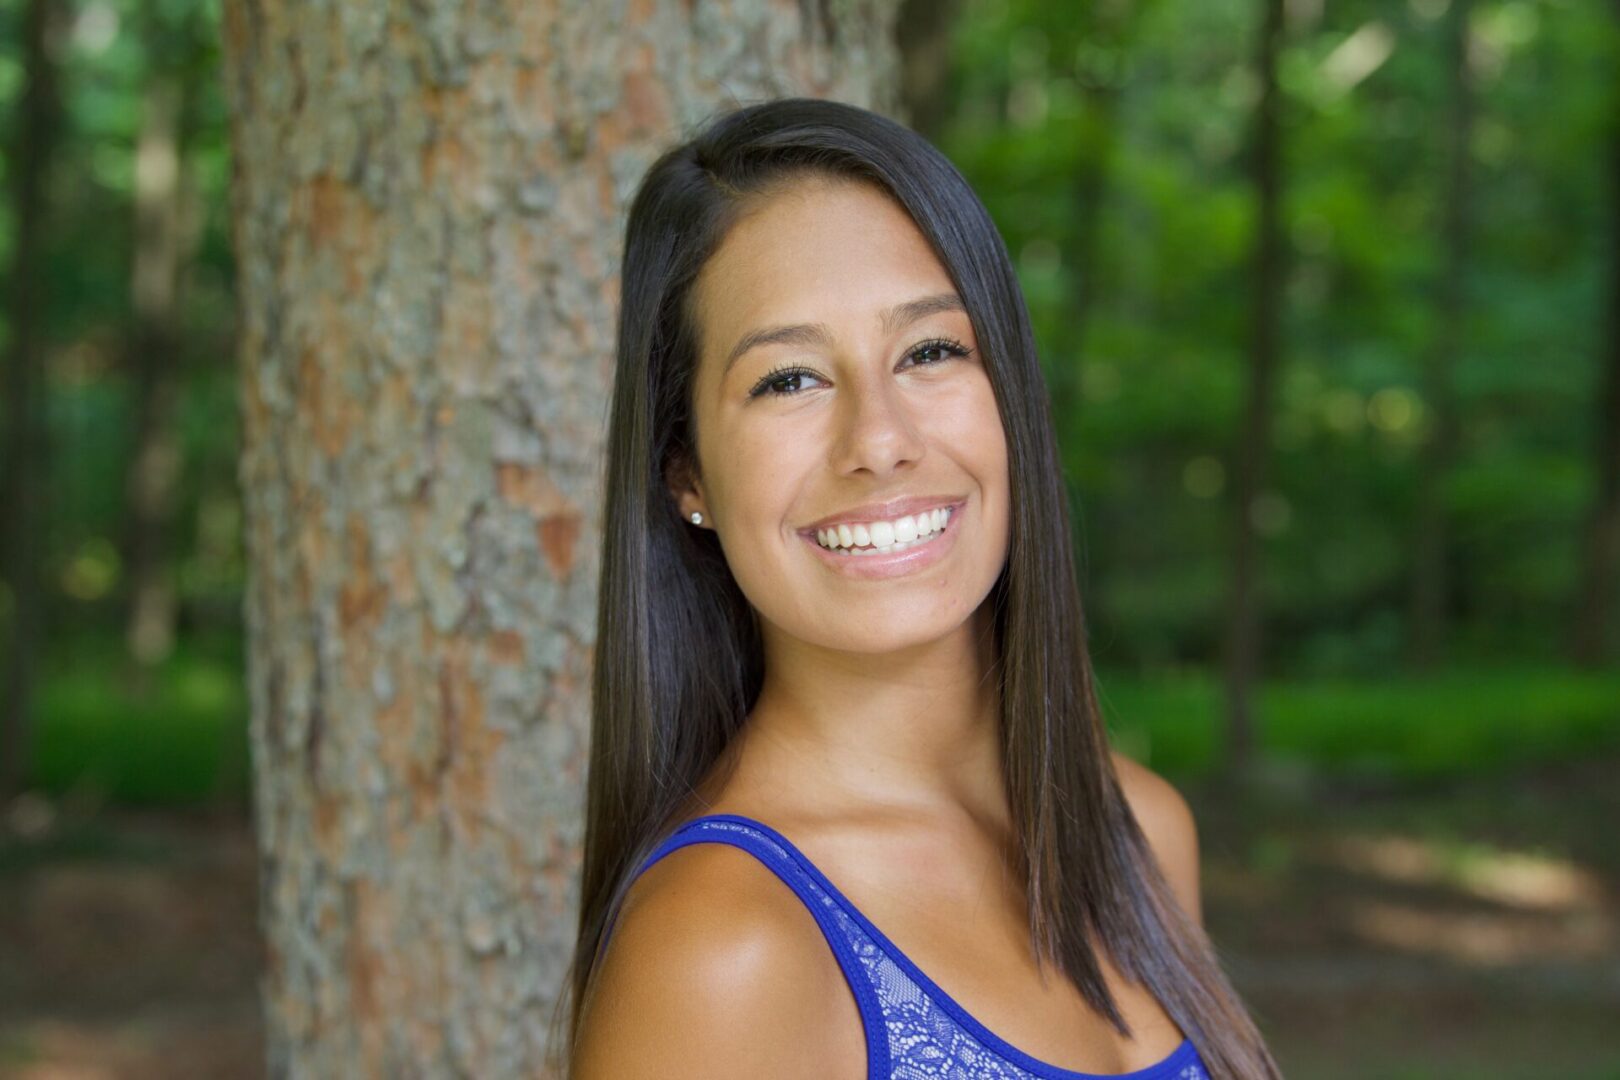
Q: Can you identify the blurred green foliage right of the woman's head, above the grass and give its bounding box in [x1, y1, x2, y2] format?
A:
[938, 0, 1620, 675]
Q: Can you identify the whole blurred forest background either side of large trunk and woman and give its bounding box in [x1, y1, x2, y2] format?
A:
[0, 0, 1620, 1077]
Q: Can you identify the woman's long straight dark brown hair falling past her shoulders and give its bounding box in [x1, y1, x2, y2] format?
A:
[552, 97, 1280, 1080]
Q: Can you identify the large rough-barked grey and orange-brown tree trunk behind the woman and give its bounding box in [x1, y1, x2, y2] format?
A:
[224, 0, 897, 1077]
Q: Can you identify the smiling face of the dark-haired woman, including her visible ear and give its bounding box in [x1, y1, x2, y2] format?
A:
[676, 180, 1009, 653]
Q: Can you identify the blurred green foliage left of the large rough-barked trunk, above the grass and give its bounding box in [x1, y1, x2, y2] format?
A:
[0, 0, 243, 636]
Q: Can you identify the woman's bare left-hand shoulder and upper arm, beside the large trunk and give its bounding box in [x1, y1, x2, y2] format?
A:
[569, 844, 847, 1080]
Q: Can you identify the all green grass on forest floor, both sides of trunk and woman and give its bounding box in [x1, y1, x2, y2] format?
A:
[22, 638, 1620, 806]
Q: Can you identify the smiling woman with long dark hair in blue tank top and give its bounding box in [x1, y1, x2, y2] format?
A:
[552, 99, 1278, 1080]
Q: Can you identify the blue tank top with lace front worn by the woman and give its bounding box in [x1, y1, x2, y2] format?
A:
[609, 814, 1209, 1080]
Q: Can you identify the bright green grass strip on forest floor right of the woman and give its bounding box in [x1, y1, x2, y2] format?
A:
[1098, 667, 1620, 779]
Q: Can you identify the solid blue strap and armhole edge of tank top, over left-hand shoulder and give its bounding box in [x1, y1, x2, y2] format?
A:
[603, 814, 889, 1080]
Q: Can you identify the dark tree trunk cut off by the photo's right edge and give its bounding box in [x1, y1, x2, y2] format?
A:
[1570, 5, 1620, 667]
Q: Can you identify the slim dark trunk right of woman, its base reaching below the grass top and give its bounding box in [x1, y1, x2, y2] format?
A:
[1225, 0, 1283, 774]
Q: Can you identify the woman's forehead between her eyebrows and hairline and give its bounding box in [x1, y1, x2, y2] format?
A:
[695, 180, 954, 355]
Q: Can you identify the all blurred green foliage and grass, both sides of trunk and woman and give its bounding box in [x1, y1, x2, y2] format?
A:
[0, 0, 1620, 803]
